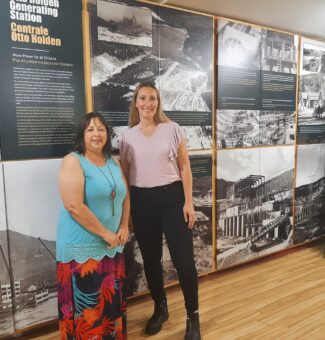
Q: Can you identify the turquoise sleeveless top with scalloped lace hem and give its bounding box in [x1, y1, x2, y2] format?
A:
[56, 153, 126, 263]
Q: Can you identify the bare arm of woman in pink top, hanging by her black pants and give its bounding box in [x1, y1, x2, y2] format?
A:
[177, 141, 196, 229]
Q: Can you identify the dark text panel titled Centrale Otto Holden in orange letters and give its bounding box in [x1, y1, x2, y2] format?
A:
[0, 0, 84, 160]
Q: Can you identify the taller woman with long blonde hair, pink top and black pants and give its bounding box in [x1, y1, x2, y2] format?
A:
[120, 83, 201, 340]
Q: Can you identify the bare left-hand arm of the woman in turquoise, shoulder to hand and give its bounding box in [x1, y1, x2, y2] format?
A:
[59, 154, 118, 248]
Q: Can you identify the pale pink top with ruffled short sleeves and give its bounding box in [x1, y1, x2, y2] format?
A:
[120, 122, 185, 188]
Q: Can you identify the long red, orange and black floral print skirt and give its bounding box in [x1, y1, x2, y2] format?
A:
[57, 253, 127, 340]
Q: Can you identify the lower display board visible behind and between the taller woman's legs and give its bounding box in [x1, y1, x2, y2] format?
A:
[125, 151, 213, 296]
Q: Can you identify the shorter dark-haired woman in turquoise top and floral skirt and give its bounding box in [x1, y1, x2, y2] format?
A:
[57, 113, 130, 339]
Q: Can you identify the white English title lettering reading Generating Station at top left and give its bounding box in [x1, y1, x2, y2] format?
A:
[9, 0, 60, 23]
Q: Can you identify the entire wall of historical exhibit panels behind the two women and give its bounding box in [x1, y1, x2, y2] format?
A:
[0, 0, 325, 337]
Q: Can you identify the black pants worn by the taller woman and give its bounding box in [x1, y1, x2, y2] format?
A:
[131, 181, 198, 313]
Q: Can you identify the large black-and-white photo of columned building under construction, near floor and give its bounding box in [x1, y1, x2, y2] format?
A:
[216, 146, 294, 269]
